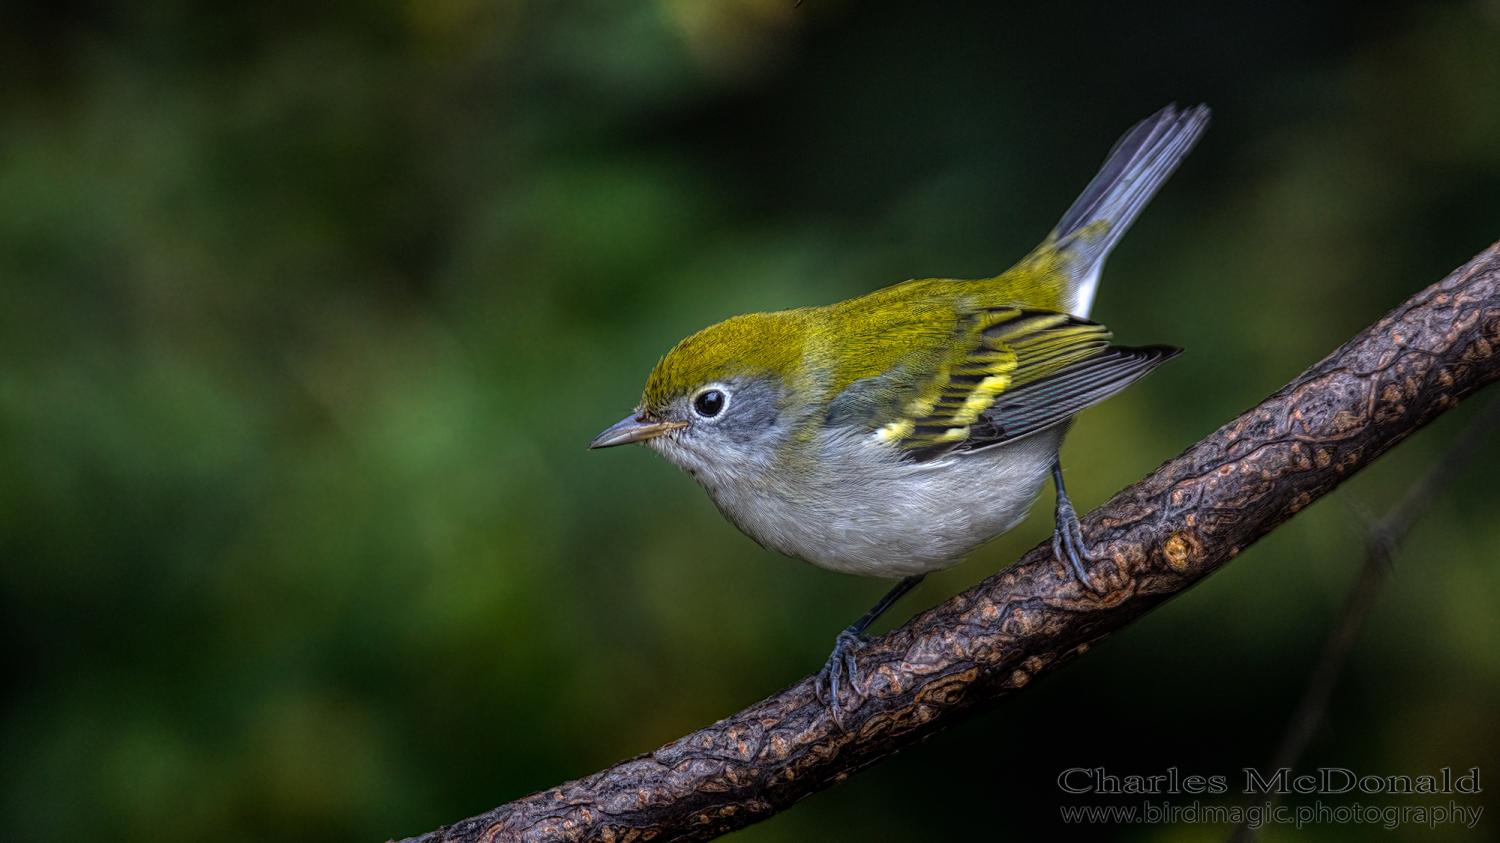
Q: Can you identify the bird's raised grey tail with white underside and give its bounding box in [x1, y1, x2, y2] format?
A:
[1044, 105, 1209, 318]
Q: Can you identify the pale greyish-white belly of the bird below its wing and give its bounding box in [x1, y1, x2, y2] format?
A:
[699, 425, 1067, 578]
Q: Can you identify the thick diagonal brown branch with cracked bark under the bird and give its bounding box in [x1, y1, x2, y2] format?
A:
[396, 245, 1500, 843]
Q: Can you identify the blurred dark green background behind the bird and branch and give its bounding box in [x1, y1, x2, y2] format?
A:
[0, 0, 1500, 843]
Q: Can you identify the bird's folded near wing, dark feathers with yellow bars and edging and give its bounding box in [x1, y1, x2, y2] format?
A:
[840, 308, 1179, 461]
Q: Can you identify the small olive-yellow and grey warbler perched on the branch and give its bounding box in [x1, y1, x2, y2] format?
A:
[590, 105, 1209, 725]
